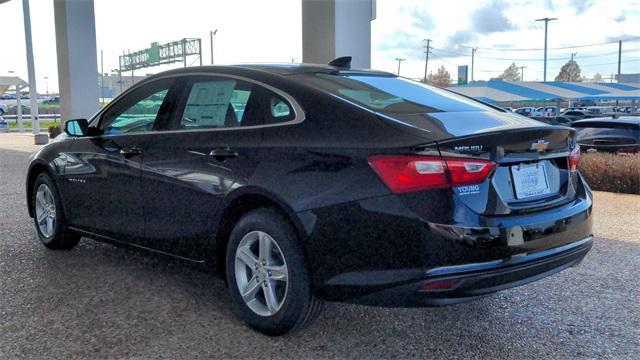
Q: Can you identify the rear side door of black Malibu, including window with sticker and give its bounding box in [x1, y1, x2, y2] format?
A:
[142, 75, 293, 260]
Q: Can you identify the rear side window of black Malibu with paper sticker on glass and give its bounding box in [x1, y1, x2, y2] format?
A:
[179, 77, 295, 129]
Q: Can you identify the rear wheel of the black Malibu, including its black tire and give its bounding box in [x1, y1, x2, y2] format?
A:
[226, 208, 323, 336]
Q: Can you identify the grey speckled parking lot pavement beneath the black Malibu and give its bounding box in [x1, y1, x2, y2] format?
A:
[0, 141, 640, 359]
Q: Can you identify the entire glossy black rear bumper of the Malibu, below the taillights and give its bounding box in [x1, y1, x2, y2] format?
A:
[306, 181, 593, 307]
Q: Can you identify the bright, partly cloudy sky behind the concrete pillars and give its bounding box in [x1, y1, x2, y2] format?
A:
[0, 0, 640, 93]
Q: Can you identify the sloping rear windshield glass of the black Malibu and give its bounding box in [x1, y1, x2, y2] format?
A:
[308, 73, 497, 114]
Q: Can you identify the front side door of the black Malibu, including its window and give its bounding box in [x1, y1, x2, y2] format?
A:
[65, 80, 178, 241]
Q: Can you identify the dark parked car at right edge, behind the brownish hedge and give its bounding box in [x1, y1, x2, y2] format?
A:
[572, 116, 640, 153]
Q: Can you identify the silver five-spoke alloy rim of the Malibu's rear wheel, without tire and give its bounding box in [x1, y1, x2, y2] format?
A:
[234, 231, 289, 316]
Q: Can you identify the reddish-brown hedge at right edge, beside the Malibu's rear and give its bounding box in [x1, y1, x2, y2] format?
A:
[579, 153, 640, 194]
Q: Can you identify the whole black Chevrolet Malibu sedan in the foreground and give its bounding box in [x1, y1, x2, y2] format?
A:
[26, 61, 592, 335]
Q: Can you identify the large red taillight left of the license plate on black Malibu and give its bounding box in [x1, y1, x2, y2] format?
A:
[369, 155, 495, 193]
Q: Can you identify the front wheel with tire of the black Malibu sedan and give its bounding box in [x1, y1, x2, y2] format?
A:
[31, 173, 80, 250]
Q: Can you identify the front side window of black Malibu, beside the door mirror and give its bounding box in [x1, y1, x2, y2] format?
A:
[99, 80, 173, 135]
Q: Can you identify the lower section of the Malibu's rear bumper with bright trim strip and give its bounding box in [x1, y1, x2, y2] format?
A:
[353, 237, 593, 307]
